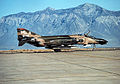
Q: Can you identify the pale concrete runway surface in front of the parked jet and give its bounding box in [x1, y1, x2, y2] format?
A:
[0, 50, 120, 84]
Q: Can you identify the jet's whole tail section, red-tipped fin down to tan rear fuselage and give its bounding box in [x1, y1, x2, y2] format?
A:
[17, 28, 44, 47]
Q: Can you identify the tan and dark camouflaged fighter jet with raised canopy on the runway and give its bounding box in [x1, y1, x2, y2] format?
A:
[17, 28, 108, 52]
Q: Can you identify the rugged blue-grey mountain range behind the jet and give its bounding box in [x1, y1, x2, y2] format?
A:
[0, 3, 120, 49]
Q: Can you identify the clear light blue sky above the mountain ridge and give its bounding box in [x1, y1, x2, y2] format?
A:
[0, 0, 120, 17]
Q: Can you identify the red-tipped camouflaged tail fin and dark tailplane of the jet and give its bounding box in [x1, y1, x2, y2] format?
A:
[17, 28, 37, 46]
